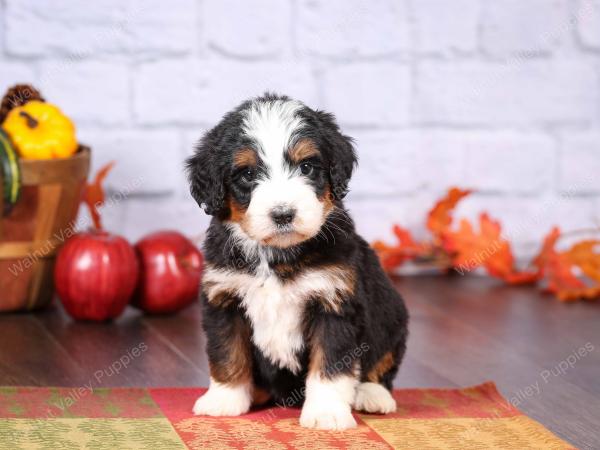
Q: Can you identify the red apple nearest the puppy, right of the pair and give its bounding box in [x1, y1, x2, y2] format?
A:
[133, 231, 203, 314]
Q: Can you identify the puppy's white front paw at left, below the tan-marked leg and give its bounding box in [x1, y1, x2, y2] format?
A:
[193, 383, 252, 416]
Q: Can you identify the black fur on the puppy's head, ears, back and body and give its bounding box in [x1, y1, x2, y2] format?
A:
[187, 95, 408, 405]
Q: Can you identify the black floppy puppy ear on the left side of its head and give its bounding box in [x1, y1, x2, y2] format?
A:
[186, 136, 225, 216]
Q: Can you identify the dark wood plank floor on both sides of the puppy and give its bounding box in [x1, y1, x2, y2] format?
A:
[0, 276, 600, 449]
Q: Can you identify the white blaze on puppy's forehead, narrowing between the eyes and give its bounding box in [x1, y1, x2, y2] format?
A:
[243, 100, 303, 178]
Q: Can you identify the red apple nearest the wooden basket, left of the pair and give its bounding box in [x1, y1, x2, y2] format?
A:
[54, 230, 139, 321]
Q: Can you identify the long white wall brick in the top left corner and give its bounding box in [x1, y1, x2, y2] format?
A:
[5, 0, 196, 57]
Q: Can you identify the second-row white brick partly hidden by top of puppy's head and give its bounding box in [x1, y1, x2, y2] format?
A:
[134, 61, 316, 125]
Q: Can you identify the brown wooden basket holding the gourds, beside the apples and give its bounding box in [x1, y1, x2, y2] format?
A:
[0, 147, 90, 312]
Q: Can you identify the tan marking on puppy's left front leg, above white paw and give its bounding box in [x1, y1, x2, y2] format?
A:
[210, 317, 252, 385]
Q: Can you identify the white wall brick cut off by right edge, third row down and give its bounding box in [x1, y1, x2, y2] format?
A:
[559, 132, 600, 194]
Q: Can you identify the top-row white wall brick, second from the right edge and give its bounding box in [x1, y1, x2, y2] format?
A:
[481, 0, 570, 55]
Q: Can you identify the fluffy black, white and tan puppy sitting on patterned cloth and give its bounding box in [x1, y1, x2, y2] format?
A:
[187, 94, 408, 430]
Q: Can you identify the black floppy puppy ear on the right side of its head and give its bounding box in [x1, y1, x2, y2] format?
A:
[317, 111, 358, 200]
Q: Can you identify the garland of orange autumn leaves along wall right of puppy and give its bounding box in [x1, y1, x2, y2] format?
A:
[373, 188, 600, 301]
